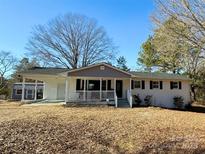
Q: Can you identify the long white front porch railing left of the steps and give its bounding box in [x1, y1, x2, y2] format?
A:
[68, 90, 115, 101]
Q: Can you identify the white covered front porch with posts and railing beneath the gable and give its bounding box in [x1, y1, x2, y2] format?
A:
[65, 77, 132, 107]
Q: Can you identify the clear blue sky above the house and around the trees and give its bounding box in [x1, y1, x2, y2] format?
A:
[0, 0, 154, 69]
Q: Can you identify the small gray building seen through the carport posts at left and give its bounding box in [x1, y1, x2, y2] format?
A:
[11, 83, 44, 100]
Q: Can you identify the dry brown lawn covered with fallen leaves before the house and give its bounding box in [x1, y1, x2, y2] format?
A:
[0, 103, 205, 153]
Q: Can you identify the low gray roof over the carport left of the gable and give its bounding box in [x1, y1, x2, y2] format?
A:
[19, 67, 68, 75]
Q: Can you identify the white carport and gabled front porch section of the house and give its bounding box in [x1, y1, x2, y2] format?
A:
[18, 63, 135, 107]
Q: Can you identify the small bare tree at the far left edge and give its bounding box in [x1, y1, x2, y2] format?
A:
[0, 51, 16, 90]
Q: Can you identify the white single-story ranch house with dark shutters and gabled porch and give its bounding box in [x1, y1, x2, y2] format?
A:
[18, 63, 191, 108]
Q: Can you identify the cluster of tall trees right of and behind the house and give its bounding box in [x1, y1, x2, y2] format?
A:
[138, 0, 205, 100]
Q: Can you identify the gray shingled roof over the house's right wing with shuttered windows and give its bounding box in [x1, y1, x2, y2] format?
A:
[130, 71, 190, 80]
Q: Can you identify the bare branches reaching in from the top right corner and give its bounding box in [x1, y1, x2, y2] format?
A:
[152, 0, 205, 50]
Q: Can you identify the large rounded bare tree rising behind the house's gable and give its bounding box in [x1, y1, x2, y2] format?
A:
[26, 14, 115, 68]
